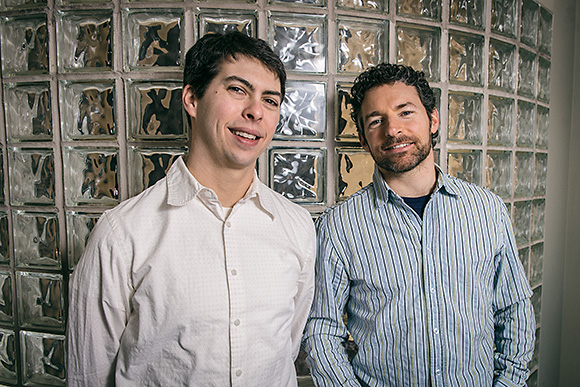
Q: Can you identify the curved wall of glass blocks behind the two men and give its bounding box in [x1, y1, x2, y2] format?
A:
[0, 0, 552, 386]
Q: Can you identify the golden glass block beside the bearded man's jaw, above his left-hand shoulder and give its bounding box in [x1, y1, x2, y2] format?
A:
[336, 148, 375, 200]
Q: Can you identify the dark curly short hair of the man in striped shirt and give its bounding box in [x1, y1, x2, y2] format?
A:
[351, 63, 439, 145]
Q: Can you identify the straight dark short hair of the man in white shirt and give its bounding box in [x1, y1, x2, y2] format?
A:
[183, 31, 286, 98]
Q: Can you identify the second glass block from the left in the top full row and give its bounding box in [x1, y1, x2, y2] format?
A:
[56, 10, 113, 72]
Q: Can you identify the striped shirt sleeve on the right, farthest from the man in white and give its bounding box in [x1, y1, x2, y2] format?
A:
[494, 204, 536, 386]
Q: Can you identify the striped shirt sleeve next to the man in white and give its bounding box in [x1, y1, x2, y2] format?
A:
[304, 220, 360, 387]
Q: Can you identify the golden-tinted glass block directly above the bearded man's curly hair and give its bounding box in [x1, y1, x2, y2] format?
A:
[397, 23, 441, 81]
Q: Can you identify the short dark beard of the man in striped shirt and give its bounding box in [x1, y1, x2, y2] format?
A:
[370, 137, 432, 173]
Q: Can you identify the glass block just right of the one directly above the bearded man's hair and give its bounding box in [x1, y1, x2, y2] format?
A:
[449, 30, 484, 86]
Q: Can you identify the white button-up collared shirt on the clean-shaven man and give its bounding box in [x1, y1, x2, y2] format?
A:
[68, 159, 315, 386]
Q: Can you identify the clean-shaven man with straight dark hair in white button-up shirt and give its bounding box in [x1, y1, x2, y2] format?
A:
[68, 33, 315, 386]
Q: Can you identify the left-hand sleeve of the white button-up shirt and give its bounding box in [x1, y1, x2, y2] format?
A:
[67, 214, 131, 387]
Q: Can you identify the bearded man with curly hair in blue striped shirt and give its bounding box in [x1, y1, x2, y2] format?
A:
[305, 64, 535, 387]
